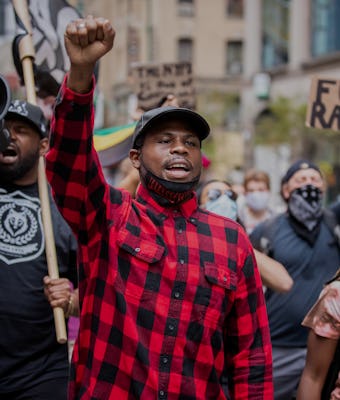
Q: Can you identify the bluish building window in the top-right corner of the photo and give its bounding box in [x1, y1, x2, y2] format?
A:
[311, 0, 340, 57]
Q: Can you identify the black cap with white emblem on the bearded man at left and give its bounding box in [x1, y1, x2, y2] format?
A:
[5, 100, 47, 138]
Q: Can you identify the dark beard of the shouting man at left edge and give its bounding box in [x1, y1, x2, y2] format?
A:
[0, 149, 40, 184]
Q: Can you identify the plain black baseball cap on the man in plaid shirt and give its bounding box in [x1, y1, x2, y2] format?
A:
[132, 106, 210, 149]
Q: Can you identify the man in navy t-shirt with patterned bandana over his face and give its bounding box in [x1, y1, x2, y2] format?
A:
[250, 160, 340, 400]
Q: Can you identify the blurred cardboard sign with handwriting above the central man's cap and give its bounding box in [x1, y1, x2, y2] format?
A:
[130, 63, 195, 110]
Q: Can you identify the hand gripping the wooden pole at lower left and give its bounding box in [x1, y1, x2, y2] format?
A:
[44, 276, 73, 315]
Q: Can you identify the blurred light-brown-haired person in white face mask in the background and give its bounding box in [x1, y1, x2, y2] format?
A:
[239, 169, 273, 234]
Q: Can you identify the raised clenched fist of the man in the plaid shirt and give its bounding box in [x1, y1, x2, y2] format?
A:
[65, 15, 115, 93]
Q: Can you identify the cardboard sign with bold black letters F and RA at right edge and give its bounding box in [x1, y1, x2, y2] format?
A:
[306, 77, 340, 131]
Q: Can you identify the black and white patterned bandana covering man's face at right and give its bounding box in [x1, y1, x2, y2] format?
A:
[288, 185, 323, 232]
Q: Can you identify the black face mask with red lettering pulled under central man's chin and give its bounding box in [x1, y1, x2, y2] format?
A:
[140, 166, 200, 207]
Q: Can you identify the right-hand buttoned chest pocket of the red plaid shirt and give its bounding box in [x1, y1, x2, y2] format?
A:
[199, 262, 237, 329]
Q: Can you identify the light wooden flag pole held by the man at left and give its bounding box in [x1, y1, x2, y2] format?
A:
[12, 0, 67, 344]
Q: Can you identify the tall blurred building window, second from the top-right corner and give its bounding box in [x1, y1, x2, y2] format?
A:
[262, 0, 290, 69]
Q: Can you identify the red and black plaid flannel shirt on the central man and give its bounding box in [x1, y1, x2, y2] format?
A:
[46, 76, 273, 400]
